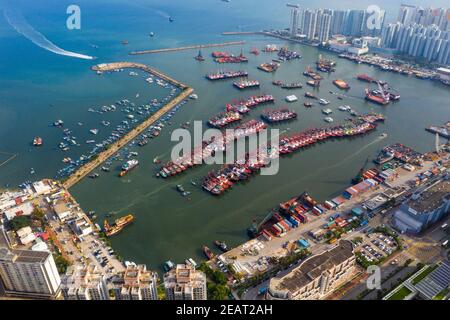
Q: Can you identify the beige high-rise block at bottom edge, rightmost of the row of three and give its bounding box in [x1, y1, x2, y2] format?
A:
[164, 264, 206, 300]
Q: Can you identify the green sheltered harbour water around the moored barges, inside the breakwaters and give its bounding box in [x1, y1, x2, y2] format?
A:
[67, 36, 450, 268]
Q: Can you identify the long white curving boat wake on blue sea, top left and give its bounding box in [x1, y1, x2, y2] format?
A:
[3, 8, 94, 60]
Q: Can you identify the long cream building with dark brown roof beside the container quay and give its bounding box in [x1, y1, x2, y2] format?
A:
[266, 240, 356, 300]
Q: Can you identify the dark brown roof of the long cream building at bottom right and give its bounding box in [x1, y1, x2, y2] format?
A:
[270, 240, 354, 292]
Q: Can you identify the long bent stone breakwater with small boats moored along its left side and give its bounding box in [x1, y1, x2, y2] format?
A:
[63, 62, 194, 189]
